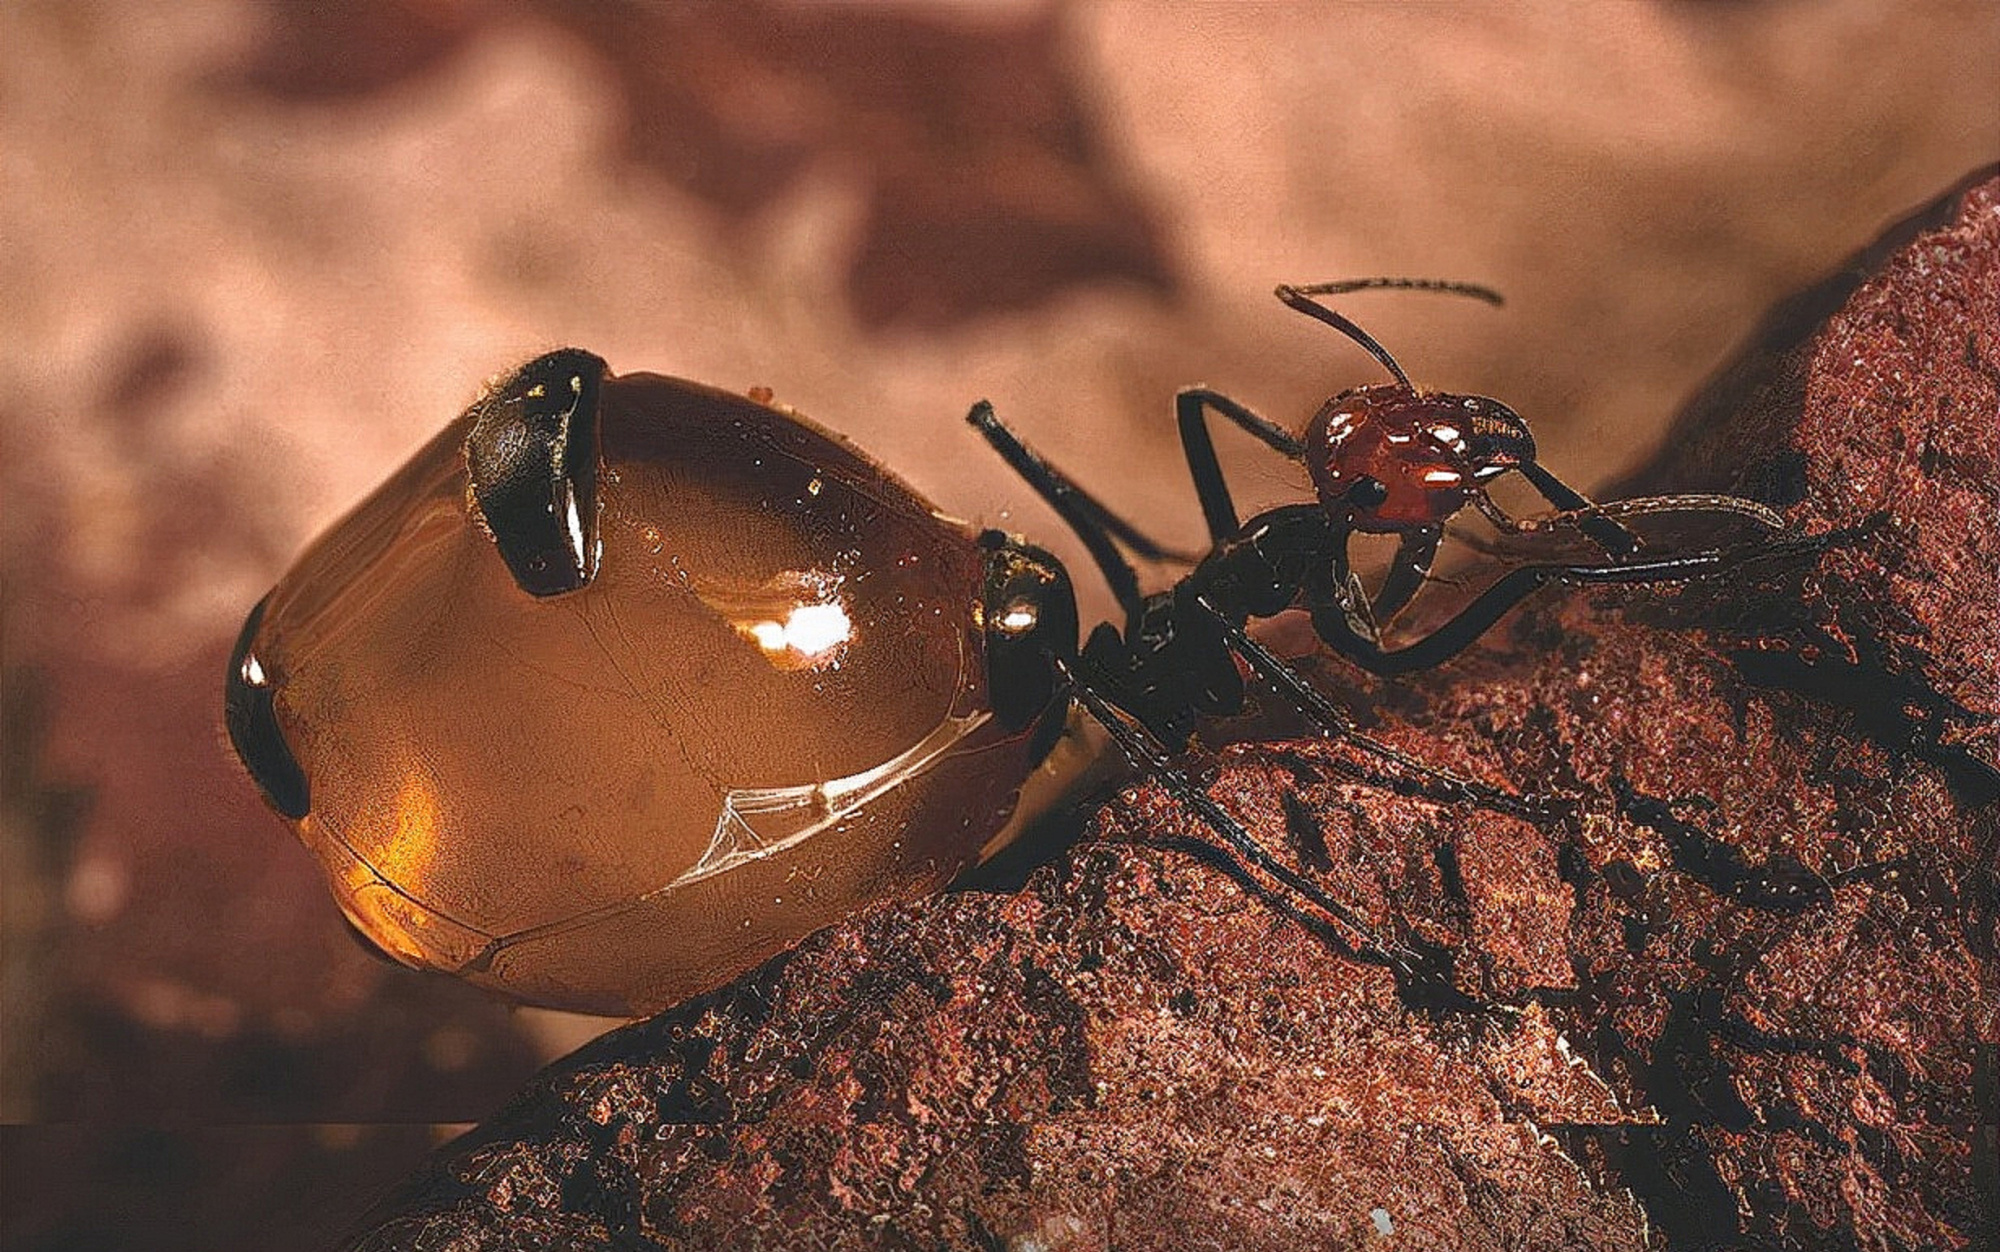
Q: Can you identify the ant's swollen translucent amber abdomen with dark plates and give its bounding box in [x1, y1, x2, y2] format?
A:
[228, 352, 1076, 1012]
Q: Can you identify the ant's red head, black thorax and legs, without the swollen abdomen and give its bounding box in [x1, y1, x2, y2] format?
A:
[966, 278, 1826, 974]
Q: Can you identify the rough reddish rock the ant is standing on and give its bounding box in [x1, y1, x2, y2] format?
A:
[336, 180, 2000, 1248]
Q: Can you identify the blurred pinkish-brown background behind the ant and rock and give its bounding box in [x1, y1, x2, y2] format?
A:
[0, 0, 2000, 1248]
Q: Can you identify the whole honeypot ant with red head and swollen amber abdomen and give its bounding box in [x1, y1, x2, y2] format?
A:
[224, 280, 1816, 1014]
